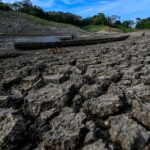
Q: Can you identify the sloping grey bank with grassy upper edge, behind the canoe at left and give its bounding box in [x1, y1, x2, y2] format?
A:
[0, 11, 85, 36]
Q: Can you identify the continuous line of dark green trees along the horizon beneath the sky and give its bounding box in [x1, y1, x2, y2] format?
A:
[0, 0, 150, 29]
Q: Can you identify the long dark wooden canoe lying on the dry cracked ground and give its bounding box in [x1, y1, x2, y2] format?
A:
[14, 35, 129, 50]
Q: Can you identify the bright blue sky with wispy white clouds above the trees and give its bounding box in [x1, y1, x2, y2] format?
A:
[3, 0, 150, 20]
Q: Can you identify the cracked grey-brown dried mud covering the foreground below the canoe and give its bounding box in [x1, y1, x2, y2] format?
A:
[0, 32, 150, 150]
